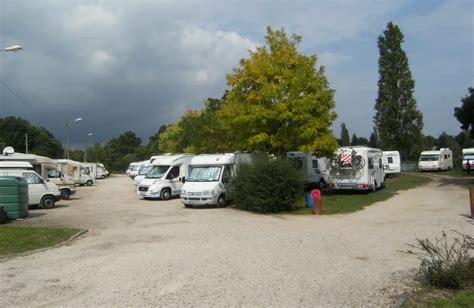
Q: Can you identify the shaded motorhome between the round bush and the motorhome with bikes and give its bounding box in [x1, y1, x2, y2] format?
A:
[286, 151, 329, 189]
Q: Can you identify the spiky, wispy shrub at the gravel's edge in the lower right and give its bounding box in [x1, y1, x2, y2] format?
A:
[409, 232, 474, 289]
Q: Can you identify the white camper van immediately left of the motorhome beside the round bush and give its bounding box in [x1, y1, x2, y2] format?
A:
[137, 154, 195, 200]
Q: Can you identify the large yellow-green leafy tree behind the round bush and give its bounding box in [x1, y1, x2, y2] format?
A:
[219, 27, 337, 155]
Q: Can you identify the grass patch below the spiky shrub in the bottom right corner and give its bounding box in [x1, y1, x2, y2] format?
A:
[403, 289, 474, 308]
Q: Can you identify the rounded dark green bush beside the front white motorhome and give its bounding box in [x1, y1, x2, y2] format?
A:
[230, 156, 304, 213]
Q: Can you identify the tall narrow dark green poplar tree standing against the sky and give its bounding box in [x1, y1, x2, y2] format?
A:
[374, 22, 423, 158]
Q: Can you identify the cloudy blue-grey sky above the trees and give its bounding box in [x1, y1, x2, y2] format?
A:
[0, 0, 474, 145]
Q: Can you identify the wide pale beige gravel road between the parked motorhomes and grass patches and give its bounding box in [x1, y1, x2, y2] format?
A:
[0, 176, 474, 307]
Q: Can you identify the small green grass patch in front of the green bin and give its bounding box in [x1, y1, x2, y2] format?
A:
[0, 225, 79, 255]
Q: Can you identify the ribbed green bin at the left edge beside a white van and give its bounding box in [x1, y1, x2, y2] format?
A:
[0, 176, 28, 219]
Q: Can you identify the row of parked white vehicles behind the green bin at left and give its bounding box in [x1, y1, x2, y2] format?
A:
[0, 147, 109, 208]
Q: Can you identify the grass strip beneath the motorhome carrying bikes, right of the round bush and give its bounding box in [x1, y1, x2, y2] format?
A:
[292, 173, 431, 215]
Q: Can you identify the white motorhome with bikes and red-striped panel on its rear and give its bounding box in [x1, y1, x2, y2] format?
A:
[329, 146, 385, 191]
